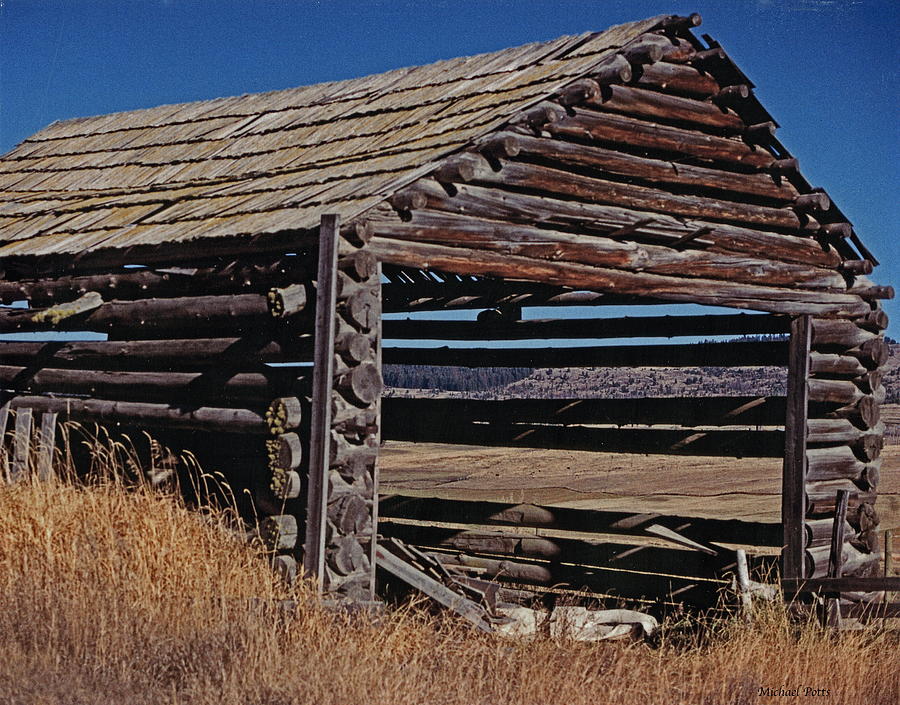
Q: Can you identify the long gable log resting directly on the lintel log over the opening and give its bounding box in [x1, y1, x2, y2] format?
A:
[373, 211, 846, 292]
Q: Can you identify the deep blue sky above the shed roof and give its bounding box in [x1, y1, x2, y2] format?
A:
[0, 0, 900, 337]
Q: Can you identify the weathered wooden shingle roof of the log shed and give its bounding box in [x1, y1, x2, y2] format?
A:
[0, 16, 666, 258]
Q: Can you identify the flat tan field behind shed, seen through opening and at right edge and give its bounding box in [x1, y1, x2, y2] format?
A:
[380, 441, 900, 528]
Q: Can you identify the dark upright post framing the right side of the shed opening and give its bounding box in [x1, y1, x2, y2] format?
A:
[781, 315, 812, 580]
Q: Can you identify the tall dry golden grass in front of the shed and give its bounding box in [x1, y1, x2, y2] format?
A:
[0, 434, 900, 705]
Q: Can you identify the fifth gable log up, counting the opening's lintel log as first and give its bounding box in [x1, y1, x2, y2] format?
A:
[486, 133, 796, 202]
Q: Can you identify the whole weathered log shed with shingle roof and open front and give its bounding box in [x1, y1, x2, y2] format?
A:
[0, 15, 893, 612]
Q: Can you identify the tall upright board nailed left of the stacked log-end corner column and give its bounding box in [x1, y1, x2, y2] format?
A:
[303, 214, 340, 591]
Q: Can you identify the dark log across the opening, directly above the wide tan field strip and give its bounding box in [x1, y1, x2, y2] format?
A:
[381, 414, 784, 458]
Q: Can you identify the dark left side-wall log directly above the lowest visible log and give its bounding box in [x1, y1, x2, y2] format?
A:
[0, 365, 310, 403]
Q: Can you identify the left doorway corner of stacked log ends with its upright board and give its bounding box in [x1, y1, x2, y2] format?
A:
[303, 216, 383, 603]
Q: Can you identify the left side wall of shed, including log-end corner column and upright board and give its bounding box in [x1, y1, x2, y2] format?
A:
[0, 220, 381, 601]
